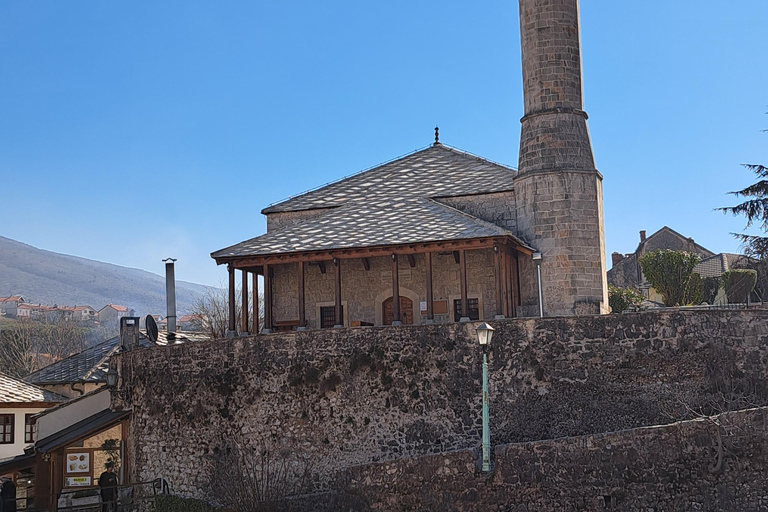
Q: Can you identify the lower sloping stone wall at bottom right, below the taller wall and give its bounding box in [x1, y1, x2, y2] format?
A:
[332, 408, 768, 512]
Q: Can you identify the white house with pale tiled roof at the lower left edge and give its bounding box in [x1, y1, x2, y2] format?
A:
[0, 373, 67, 460]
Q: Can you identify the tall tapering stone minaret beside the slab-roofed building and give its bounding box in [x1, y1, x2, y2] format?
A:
[515, 0, 608, 316]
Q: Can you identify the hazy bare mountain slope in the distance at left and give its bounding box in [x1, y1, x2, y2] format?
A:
[0, 236, 216, 316]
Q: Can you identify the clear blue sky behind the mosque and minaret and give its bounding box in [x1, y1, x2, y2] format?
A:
[0, 0, 768, 284]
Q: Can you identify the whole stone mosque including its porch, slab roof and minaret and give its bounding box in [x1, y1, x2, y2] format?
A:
[211, 0, 608, 334]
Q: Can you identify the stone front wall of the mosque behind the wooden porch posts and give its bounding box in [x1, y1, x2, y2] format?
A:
[273, 249, 496, 329]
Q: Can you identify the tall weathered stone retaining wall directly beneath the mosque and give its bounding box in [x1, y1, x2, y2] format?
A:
[114, 310, 768, 497]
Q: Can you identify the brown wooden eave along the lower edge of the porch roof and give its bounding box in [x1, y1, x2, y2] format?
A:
[214, 236, 534, 271]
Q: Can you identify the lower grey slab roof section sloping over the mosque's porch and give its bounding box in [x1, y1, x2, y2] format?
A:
[211, 197, 529, 264]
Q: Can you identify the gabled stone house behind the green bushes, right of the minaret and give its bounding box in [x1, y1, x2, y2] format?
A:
[608, 226, 749, 302]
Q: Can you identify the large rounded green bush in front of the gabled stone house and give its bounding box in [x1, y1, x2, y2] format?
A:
[638, 249, 704, 307]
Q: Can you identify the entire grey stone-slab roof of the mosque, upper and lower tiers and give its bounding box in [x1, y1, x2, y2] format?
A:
[211, 145, 516, 258]
